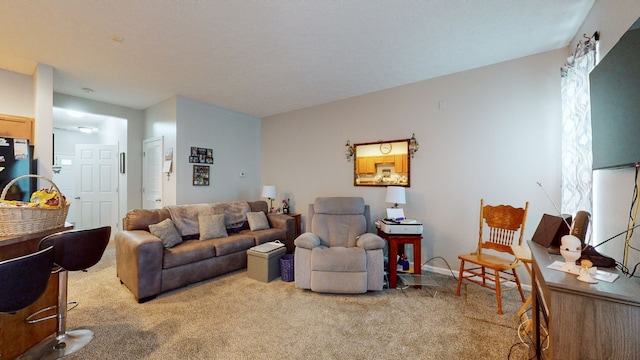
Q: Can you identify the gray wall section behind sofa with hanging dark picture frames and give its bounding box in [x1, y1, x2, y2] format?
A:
[174, 96, 261, 204]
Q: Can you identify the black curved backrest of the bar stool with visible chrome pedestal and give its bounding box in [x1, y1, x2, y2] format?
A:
[39, 226, 111, 271]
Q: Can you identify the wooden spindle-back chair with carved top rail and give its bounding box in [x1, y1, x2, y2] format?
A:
[456, 199, 529, 314]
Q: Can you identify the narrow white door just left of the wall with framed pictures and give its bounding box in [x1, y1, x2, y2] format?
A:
[142, 137, 163, 209]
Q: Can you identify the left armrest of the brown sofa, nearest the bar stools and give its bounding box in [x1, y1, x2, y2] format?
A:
[114, 230, 164, 302]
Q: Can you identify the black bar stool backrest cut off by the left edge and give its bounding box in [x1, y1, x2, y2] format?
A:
[0, 246, 54, 313]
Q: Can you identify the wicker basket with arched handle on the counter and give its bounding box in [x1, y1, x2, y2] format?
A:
[0, 175, 69, 236]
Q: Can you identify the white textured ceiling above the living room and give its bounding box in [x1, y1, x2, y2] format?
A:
[0, 0, 594, 117]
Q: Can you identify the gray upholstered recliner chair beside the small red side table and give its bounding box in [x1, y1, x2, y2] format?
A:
[294, 197, 386, 294]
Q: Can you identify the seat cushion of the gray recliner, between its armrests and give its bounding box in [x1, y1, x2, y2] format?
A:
[311, 246, 367, 273]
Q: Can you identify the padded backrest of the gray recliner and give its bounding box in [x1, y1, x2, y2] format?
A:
[310, 197, 368, 247]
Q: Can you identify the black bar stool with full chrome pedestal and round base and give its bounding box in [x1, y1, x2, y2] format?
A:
[22, 226, 111, 359]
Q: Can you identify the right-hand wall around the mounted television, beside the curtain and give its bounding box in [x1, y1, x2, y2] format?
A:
[571, 0, 640, 266]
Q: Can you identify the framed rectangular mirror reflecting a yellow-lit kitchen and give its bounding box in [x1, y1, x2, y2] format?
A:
[353, 139, 411, 187]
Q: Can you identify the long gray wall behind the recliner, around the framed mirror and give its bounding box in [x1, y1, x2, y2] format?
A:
[261, 49, 566, 278]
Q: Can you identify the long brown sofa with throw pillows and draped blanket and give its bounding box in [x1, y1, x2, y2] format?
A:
[114, 201, 296, 303]
